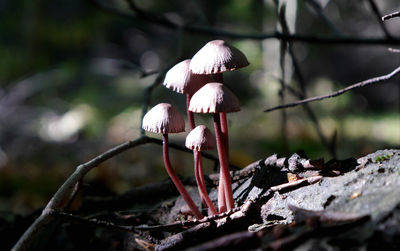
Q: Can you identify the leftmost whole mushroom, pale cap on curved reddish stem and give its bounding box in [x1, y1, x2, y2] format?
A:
[142, 103, 203, 219]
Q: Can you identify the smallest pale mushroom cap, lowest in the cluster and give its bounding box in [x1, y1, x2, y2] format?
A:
[185, 125, 215, 151]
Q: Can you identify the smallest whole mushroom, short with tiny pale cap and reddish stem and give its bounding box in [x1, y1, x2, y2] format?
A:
[185, 125, 217, 215]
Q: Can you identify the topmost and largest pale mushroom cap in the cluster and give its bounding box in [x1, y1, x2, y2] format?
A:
[190, 40, 249, 74]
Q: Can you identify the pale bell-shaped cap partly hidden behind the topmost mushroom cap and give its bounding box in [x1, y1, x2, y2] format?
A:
[163, 59, 212, 95]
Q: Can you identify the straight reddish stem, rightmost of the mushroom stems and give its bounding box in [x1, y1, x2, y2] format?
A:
[214, 113, 234, 210]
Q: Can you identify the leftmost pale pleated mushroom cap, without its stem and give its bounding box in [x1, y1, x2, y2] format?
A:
[142, 103, 185, 134]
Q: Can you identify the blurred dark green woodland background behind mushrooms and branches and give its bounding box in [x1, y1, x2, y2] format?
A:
[0, 0, 400, 215]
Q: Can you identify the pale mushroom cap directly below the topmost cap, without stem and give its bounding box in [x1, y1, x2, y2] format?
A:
[189, 82, 240, 113]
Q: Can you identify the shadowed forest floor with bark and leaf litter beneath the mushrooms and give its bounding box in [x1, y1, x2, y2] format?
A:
[0, 150, 400, 250]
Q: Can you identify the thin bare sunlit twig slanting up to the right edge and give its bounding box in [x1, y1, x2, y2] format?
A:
[264, 67, 400, 112]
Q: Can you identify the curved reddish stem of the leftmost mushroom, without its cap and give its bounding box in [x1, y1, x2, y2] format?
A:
[163, 133, 204, 220]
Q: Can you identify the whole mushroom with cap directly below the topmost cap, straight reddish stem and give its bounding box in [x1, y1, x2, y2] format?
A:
[189, 82, 240, 212]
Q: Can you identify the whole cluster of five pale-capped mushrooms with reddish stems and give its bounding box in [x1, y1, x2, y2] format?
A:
[143, 40, 249, 219]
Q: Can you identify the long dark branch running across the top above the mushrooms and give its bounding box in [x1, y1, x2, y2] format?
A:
[90, 1, 400, 45]
